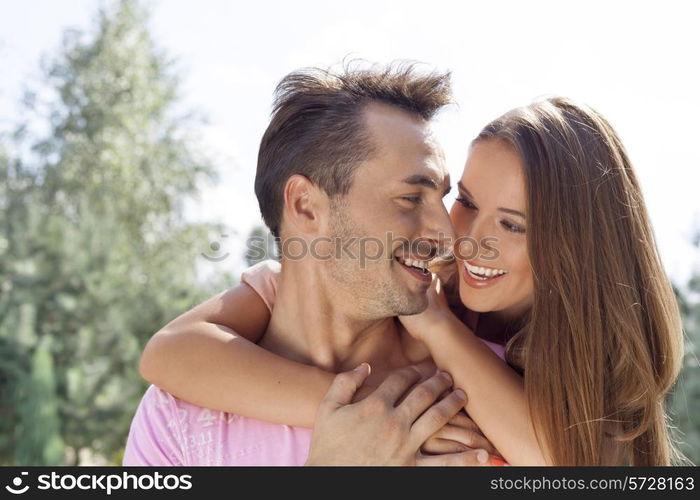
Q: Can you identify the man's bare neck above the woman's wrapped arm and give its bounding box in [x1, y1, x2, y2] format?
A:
[260, 262, 408, 375]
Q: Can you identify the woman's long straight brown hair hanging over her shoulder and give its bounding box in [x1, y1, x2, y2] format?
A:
[475, 98, 683, 465]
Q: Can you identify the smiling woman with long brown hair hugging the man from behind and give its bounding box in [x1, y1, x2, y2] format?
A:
[141, 98, 682, 465]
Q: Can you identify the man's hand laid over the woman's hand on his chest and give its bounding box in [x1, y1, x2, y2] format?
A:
[306, 363, 488, 465]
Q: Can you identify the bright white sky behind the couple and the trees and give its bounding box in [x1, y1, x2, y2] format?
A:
[0, 0, 700, 283]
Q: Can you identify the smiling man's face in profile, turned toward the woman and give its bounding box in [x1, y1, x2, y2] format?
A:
[327, 104, 452, 318]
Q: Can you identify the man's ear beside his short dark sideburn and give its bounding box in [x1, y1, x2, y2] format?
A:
[284, 174, 327, 234]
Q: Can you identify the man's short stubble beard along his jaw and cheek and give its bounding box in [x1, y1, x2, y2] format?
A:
[326, 202, 428, 319]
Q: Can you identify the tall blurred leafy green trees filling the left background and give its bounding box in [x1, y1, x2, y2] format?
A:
[0, 0, 217, 465]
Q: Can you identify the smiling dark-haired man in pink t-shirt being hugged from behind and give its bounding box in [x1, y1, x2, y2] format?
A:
[124, 62, 492, 465]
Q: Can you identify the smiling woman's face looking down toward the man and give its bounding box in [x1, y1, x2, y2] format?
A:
[450, 140, 533, 318]
